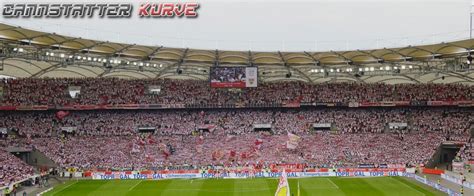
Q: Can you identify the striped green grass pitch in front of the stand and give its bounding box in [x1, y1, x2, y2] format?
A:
[45, 177, 444, 196]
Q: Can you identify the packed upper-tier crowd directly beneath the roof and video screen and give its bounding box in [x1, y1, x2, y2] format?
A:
[0, 78, 474, 105]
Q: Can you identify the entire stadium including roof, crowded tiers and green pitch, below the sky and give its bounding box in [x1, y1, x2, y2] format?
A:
[0, 0, 474, 196]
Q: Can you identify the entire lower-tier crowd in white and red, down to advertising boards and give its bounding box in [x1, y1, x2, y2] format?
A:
[0, 108, 474, 171]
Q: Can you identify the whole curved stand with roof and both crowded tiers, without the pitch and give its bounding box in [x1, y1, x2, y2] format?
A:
[0, 24, 474, 194]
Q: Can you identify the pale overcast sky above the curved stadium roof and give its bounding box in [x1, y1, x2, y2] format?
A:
[0, 0, 471, 51]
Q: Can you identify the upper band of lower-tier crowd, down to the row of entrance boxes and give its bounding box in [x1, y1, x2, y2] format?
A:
[0, 108, 474, 137]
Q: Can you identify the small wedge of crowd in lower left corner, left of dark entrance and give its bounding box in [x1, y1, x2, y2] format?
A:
[0, 149, 34, 187]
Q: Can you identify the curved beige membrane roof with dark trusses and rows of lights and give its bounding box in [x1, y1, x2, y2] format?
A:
[0, 24, 474, 83]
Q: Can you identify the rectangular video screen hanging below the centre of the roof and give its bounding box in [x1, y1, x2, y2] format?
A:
[209, 67, 258, 88]
